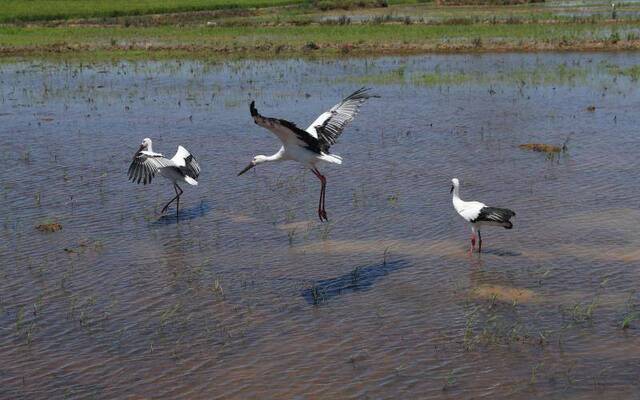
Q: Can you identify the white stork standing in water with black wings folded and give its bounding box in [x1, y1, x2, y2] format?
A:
[451, 178, 516, 253]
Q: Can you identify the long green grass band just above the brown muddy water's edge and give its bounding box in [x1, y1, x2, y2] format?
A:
[0, 24, 631, 48]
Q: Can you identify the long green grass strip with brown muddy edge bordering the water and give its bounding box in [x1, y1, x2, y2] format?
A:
[0, 23, 640, 56]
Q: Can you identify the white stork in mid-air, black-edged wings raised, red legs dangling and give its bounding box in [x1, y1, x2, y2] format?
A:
[238, 88, 378, 221]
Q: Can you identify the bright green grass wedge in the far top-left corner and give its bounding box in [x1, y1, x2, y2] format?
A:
[0, 0, 305, 22]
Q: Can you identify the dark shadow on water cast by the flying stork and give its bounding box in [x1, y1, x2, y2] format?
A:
[302, 260, 411, 305]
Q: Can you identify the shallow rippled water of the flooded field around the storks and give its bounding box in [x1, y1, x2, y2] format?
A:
[0, 53, 640, 399]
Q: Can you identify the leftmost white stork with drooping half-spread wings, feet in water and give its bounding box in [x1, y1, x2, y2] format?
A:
[129, 138, 200, 218]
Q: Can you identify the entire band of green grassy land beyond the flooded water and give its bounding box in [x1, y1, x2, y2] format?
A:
[0, 0, 640, 57]
